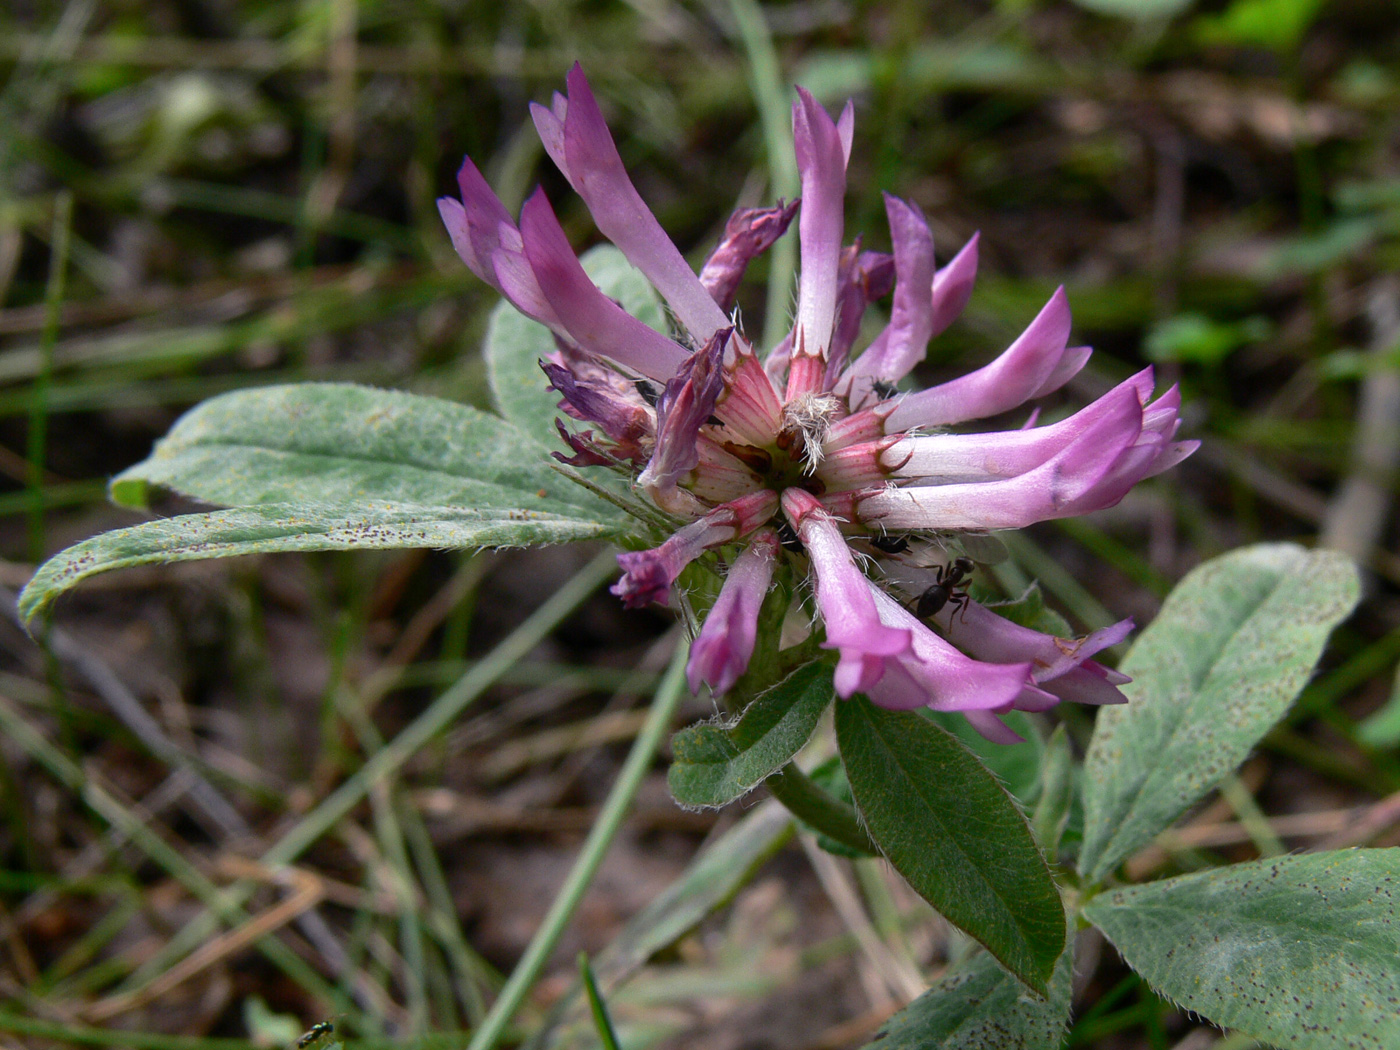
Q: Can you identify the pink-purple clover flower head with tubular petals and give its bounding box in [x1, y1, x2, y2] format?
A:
[438, 66, 1197, 739]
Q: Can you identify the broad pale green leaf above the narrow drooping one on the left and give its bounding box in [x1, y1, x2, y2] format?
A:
[112, 384, 619, 521]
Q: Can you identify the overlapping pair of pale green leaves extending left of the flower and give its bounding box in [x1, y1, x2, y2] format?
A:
[21, 384, 641, 617]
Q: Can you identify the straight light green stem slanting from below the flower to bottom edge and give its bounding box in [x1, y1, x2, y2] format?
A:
[466, 643, 690, 1050]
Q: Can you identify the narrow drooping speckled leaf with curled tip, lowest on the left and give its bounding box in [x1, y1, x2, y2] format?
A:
[20, 501, 617, 620]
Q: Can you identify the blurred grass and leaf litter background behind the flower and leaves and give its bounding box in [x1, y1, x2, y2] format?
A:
[0, 0, 1400, 1050]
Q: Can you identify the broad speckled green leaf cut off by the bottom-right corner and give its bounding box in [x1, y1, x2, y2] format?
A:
[1084, 848, 1400, 1050]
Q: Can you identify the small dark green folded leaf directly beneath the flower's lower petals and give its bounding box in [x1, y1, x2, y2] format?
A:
[666, 664, 833, 808]
